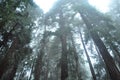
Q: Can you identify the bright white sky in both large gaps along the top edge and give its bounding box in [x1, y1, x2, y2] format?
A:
[34, 0, 110, 13]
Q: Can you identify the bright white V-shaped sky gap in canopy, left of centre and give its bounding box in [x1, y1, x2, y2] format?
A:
[34, 0, 56, 13]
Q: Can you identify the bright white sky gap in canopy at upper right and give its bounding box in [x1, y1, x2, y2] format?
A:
[88, 0, 110, 13]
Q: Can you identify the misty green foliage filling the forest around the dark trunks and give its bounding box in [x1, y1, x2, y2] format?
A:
[0, 0, 120, 80]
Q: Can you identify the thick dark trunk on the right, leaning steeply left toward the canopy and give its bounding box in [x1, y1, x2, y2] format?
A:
[79, 11, 120, 80]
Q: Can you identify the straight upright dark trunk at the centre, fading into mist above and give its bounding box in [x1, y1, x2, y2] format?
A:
[59, 10, 68, 80]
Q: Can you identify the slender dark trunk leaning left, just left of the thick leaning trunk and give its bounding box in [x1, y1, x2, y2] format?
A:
[79, 29, 97, 80]
